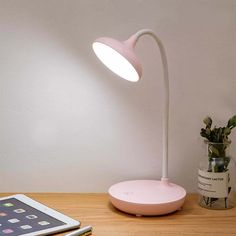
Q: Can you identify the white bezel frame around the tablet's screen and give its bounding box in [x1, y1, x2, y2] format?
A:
[0, 194, 80, 236]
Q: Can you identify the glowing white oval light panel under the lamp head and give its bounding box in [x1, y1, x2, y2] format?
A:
[93, 42, 139, 82]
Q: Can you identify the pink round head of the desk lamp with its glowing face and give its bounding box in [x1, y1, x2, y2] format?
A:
[93, 38, 142, 82]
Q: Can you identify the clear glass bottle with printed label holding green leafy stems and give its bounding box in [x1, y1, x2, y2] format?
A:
[198, 115, 236, 209]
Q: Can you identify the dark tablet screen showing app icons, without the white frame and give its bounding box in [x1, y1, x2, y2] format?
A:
[0, 198, 65, 236]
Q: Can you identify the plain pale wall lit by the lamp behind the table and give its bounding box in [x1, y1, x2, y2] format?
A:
[0, 0, 236, 192]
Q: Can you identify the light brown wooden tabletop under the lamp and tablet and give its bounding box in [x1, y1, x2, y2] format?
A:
[0, 193, 236, 236]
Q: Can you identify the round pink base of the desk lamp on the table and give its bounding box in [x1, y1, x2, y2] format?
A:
[108, 178, 186, 216]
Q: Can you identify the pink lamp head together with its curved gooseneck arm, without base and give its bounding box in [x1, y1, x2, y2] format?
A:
[93, 29, 169, 180]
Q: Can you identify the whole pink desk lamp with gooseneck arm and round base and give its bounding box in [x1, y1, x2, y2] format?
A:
[93, 29, 186, 216]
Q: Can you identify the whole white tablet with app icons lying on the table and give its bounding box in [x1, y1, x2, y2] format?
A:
[0, 194, 80, 236]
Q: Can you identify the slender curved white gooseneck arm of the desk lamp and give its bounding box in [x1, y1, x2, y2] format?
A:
[135, 29, 169, 179]
